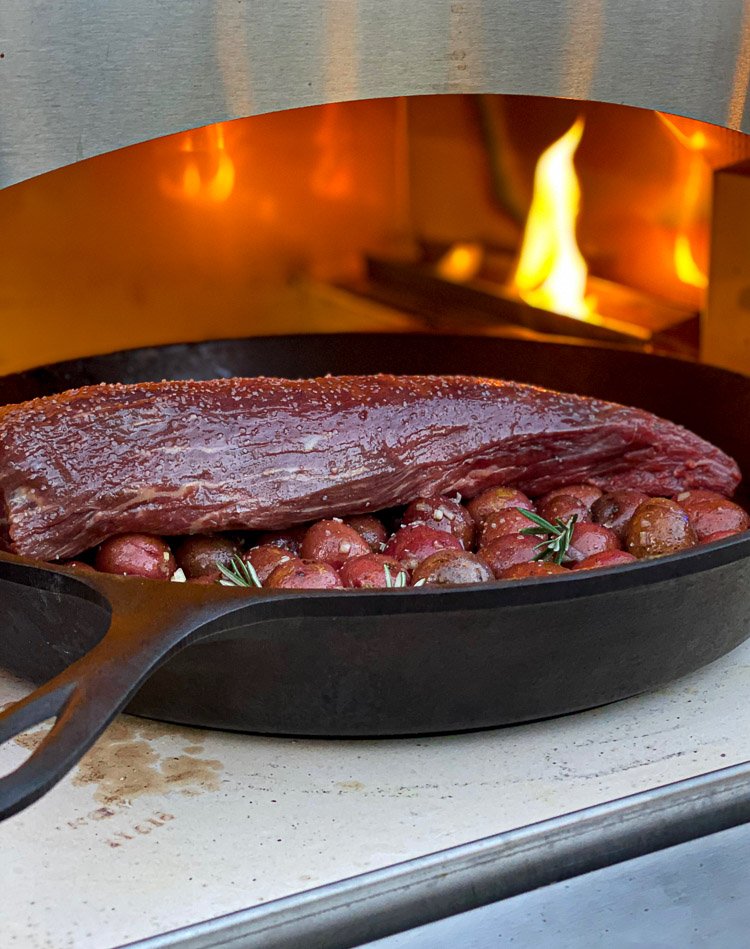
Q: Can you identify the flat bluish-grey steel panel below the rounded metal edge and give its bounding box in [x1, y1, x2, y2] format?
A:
[362, 824, 750, 949]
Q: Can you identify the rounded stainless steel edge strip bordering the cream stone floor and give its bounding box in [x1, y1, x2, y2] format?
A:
[123, 763, 750, 949]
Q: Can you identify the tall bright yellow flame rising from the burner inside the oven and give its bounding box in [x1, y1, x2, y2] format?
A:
[513, 117, 593, 319]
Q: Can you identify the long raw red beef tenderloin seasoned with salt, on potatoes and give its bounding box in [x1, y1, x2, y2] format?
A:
[0, 376, 739, 560]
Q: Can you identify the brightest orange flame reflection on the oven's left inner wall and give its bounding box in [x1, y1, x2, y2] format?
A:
[161, 123, 235, 204]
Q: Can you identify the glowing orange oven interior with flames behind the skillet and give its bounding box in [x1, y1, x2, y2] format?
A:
[0, 95, 750, 372]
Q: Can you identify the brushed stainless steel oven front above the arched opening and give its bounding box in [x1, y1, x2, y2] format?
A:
[0, 0, 750, 187]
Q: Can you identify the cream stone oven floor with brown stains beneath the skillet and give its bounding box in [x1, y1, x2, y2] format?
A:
[0, 628, 750, 949]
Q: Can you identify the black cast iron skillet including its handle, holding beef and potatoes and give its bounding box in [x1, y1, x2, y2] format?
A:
[0, 335, 750, 818]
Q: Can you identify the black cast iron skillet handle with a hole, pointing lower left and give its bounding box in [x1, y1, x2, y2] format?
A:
[0, 580, 254, 820]
